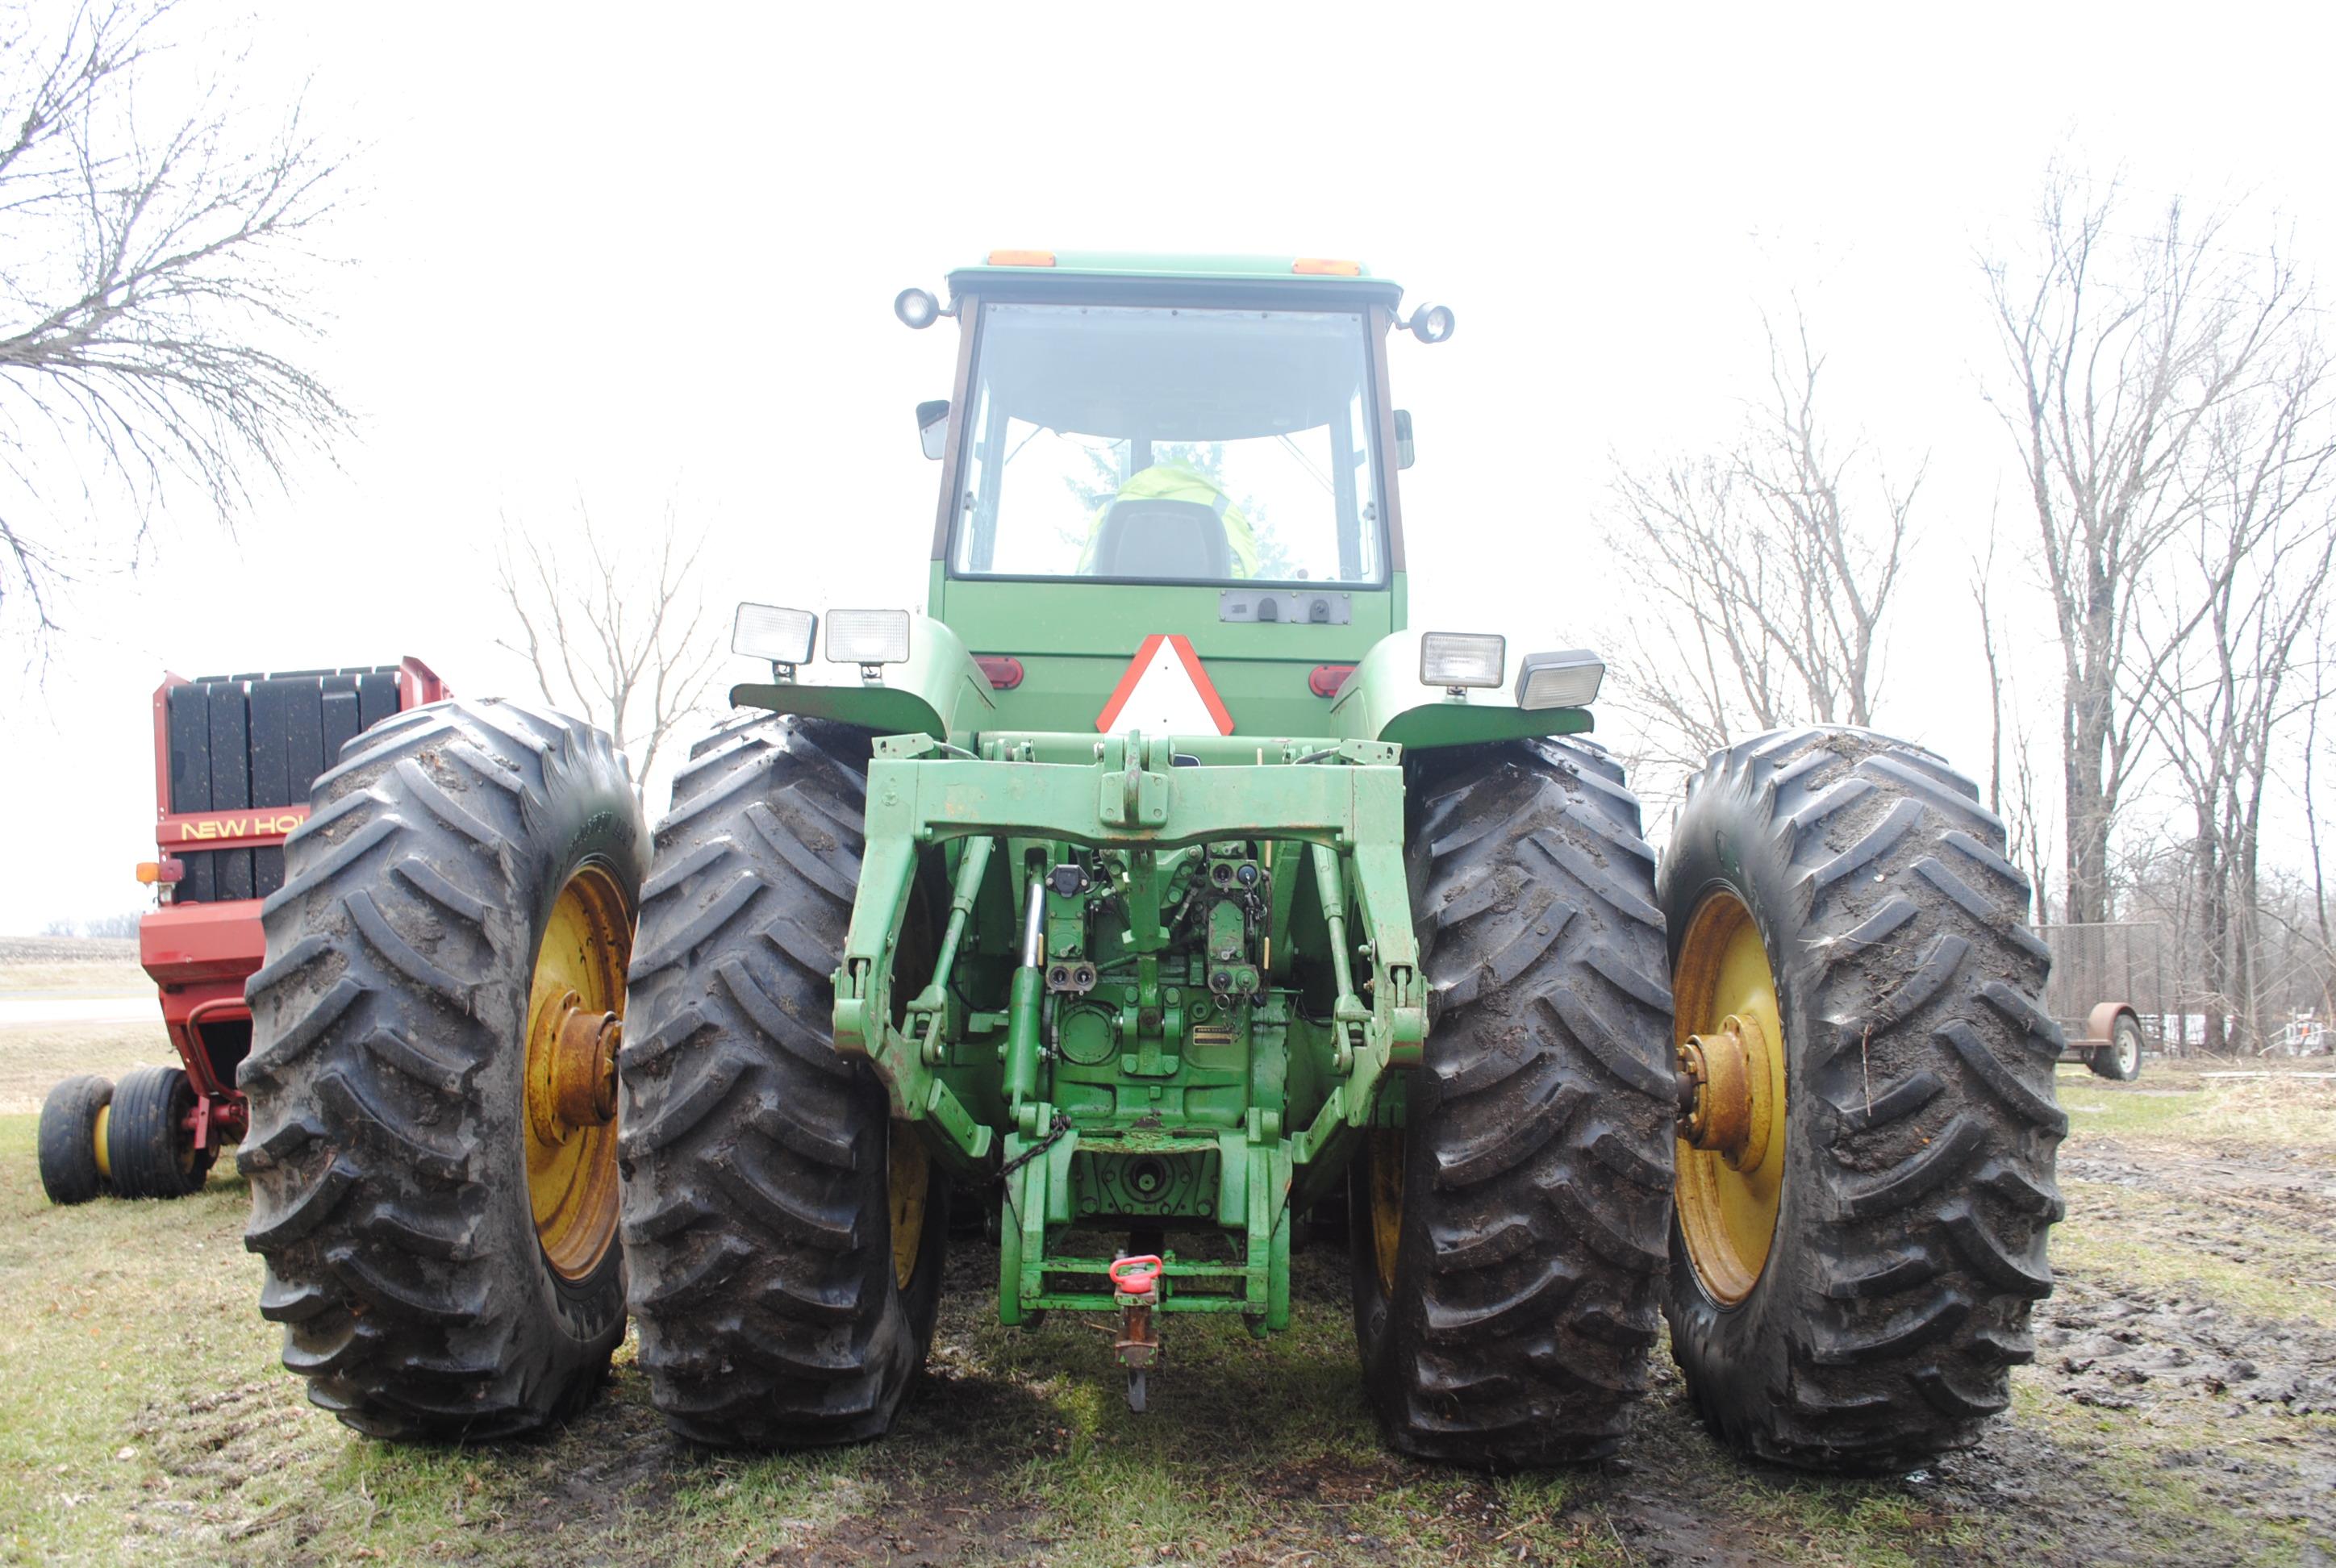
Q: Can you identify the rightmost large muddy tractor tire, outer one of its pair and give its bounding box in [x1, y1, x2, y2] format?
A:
[1661, 729, 2067, 1472]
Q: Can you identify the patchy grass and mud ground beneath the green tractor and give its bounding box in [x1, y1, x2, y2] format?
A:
[0, 1023, 2336, 1568]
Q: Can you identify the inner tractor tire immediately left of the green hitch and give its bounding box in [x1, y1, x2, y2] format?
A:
[621, 717, 949, 1449]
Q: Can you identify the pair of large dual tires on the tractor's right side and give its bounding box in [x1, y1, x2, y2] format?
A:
[1350, 729, 2067, 1472]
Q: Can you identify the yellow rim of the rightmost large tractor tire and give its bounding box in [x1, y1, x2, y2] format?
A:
[1673, 890, 1787, 1307]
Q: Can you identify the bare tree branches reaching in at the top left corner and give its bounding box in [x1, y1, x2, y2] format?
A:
[0, 0, 348, 638]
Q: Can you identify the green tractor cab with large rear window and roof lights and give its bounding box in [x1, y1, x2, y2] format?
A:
[897, 250, 1450, 732]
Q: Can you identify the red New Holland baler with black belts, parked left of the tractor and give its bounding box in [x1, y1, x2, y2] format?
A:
[40, 659, 446, 1203]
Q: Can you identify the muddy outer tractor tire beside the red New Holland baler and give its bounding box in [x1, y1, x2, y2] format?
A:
[238, 701, 649, 1442]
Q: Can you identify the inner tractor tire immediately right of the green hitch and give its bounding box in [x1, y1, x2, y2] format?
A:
[1348, 740, 1675, 1467]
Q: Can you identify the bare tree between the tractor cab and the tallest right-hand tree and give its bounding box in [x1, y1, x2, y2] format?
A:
[1612, 311, 1921, 790]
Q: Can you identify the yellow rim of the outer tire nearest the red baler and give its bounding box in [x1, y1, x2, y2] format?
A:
[521, 865, 633, 1281]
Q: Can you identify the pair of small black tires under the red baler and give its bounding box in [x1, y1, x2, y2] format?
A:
[40, 1068, 217, 1203]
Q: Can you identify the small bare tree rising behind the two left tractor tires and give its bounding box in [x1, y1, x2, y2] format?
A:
[495, 500, 722, 804]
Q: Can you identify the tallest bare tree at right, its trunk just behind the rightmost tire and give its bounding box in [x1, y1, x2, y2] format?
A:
[1981, 169, 2305, 920]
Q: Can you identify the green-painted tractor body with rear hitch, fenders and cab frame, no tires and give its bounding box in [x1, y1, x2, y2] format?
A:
[731, 252, 1591, 1332]
